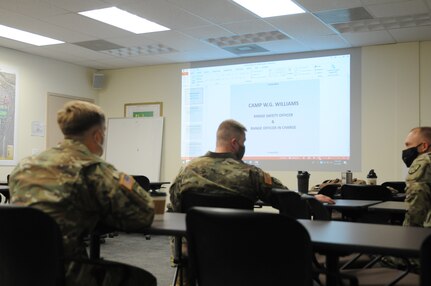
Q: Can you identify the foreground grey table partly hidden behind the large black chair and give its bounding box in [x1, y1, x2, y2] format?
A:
[147, 213, 431, 285]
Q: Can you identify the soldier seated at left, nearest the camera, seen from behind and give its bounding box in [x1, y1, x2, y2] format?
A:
[9, 101, 156, 286]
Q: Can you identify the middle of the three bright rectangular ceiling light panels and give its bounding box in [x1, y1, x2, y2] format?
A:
[79, 7, 169, 34]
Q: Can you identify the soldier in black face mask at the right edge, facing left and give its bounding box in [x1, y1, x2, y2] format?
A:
[383, 127, 431, 272]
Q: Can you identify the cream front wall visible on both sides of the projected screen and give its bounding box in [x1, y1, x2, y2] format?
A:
[99, 42, 431, 189]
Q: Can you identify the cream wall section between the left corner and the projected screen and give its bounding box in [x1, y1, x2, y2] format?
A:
[99, 64, 188, 185]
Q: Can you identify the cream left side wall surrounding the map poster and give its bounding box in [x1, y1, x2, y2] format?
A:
[0, 47, 97, 181]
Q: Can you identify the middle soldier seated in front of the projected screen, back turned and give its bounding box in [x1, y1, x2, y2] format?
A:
[169, 120, 334, 211]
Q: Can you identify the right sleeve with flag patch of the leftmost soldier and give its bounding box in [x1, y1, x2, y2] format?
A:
[85, 163, 154, 231]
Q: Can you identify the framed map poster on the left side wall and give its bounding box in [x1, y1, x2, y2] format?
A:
[0, 67, 18, 165]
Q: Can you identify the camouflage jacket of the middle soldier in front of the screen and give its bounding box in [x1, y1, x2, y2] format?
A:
[169, 152, 287, 211]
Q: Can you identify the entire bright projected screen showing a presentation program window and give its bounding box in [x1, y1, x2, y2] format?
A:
[181, 54, 360, 170]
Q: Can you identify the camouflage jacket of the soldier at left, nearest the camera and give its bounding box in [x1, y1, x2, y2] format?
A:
[10, 140, 154, 259]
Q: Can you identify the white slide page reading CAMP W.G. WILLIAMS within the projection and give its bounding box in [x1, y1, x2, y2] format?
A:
[230, 80, 320, 160]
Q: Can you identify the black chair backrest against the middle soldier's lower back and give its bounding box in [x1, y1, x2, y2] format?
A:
[181, 189, 254, 213]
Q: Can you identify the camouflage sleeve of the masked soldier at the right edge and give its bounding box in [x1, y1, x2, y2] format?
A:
[403, 154, 431, 227]
